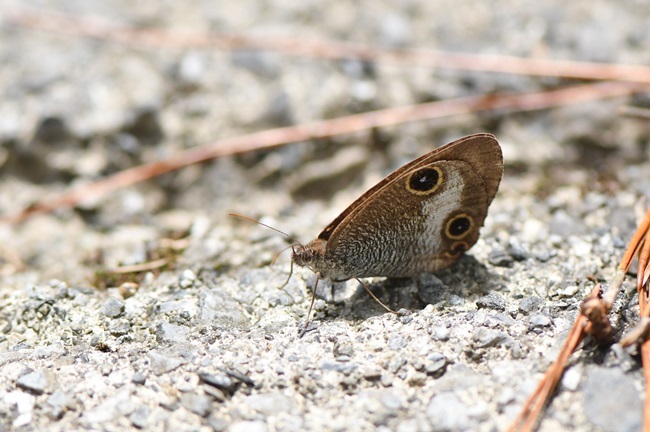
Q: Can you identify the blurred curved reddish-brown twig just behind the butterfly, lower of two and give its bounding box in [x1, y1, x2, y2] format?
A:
[0, 82, 646, 223]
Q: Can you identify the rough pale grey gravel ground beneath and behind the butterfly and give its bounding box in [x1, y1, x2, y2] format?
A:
[0, 0, 650, 432]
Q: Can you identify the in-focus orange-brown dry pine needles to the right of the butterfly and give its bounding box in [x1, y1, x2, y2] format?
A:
[509, 210, 650, 432]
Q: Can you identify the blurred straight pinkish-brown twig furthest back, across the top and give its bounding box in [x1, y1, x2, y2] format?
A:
[5, 8, 650, 84]
